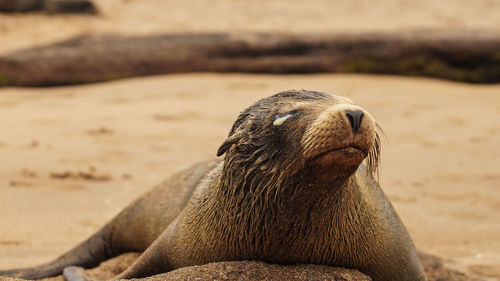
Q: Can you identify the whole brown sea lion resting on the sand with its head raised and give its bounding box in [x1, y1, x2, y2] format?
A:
[0, 90, 426, 281]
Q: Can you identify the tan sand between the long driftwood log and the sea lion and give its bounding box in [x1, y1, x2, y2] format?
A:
[0, 74, 500, 280]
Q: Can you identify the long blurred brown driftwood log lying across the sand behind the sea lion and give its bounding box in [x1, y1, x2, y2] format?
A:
[0, 32, 500, 86]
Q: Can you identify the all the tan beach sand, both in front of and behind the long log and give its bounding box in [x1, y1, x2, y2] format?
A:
[0, 0, 500, 280]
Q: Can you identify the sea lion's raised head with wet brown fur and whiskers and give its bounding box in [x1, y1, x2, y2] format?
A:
[217, 90, 380, 192]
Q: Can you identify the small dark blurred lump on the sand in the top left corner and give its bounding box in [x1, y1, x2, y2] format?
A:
[0, 0, 97, 14]
